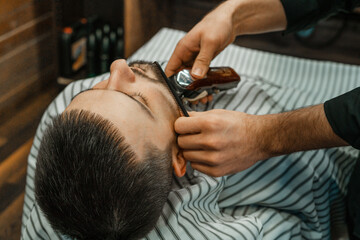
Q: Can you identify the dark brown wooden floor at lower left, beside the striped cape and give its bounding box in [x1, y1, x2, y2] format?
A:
[0, 84, 58, 240]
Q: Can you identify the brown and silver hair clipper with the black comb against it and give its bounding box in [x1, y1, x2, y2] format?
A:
[155, 62, 240, 116]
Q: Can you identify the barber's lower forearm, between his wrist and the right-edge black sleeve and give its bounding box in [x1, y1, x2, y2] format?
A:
[260, 104, 348, 156]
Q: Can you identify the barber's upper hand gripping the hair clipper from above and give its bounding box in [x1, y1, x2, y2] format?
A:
[165, 2, 235, 78]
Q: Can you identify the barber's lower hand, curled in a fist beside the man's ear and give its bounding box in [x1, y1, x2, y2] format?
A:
[175, 109, 269, 177]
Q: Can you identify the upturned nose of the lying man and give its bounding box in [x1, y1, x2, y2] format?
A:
[107, 59, 135, 90]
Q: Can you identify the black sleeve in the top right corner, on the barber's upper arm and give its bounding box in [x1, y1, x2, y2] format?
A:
[280, 0, 360, 33]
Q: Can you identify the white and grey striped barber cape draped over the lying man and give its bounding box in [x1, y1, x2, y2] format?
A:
[22, 29, 360, 240]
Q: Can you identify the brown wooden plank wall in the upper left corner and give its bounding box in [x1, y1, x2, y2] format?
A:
[0, 0, 57, 123]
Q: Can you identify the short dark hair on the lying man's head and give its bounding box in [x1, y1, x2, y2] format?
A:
[35, 110, 172, 239]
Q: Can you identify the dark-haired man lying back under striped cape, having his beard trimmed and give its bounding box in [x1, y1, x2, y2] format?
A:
[22, 60, 355, 239]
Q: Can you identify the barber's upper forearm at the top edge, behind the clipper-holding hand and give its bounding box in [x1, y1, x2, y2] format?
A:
[225, 0, 287, 35]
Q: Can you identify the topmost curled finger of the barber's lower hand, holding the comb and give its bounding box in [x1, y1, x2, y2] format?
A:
[174, 112, 202, 134]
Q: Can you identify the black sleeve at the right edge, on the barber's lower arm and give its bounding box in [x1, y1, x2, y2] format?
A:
[324, 87, 360, 149]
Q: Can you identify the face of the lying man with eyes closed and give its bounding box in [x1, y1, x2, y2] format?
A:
[66, 60, 180, 158]
